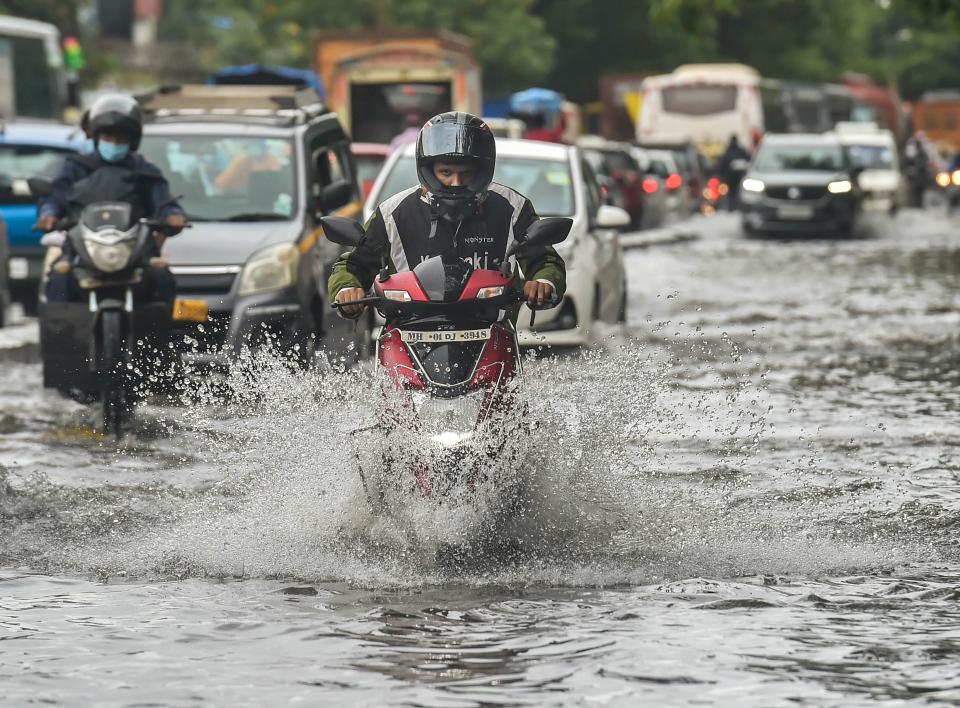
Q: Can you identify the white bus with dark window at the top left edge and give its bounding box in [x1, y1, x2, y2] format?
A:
[0, 15, 67, 120]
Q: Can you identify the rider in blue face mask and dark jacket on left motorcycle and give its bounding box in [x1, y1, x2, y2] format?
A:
[36, 94, 186, 308]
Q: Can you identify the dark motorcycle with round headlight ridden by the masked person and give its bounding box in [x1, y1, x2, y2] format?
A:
[30, 179, 182, 439]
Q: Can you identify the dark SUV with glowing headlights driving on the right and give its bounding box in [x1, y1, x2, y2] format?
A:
[740, 134, 860, 235]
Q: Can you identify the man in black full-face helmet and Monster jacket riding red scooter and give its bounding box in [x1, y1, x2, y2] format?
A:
[329, 112, 566, 317]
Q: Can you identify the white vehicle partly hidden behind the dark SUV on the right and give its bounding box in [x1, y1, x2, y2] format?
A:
[835, 122, 904, 214]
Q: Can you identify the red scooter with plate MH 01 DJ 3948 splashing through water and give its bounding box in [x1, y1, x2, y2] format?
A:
[320, 217, 572, 512]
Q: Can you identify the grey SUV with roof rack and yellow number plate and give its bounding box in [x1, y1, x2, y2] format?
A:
[141, 86, 366, 365]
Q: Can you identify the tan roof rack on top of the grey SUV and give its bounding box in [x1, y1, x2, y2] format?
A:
[136, 84, 330, 125]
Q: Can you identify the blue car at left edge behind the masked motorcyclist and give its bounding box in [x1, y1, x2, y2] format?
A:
[0, 122, 86, 315]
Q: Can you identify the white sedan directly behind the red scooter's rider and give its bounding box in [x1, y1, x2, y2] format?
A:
[364, 138, 630, 346]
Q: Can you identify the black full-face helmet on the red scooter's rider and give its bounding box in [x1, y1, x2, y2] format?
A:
[417, 111, 497, 219]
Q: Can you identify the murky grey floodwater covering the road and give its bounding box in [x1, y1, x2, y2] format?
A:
[0, 212, 960, 706]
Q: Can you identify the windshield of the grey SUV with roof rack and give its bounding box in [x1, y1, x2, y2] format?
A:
[141, 135, 297, 221]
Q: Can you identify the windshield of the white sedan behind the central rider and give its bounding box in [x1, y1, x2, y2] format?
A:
[377, 156, 574, 216]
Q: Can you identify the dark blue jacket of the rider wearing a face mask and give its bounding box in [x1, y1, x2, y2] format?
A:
[39, 153, 183, 219]
